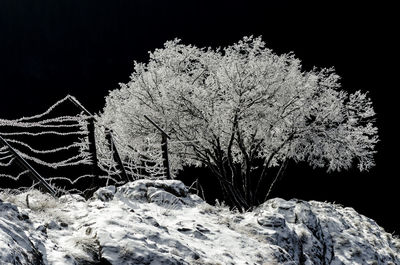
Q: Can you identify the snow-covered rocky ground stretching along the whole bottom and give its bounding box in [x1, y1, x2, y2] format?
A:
[0, 180, 400, 265]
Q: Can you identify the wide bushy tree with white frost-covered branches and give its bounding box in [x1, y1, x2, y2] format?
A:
[99, 37, 378, 209]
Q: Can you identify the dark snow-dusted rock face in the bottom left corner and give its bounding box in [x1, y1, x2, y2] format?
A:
[0, 201, 43, 265]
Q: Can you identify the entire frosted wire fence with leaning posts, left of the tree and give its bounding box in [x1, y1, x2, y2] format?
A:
[0, 95, 168, 197]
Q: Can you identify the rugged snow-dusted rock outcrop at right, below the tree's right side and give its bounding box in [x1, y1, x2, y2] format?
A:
[244, 198, 400, 265]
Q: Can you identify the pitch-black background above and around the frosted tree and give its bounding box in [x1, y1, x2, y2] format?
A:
[0, 0, 400, 234]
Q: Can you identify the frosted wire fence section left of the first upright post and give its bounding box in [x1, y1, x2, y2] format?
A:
[0, 96, 114, 193]
